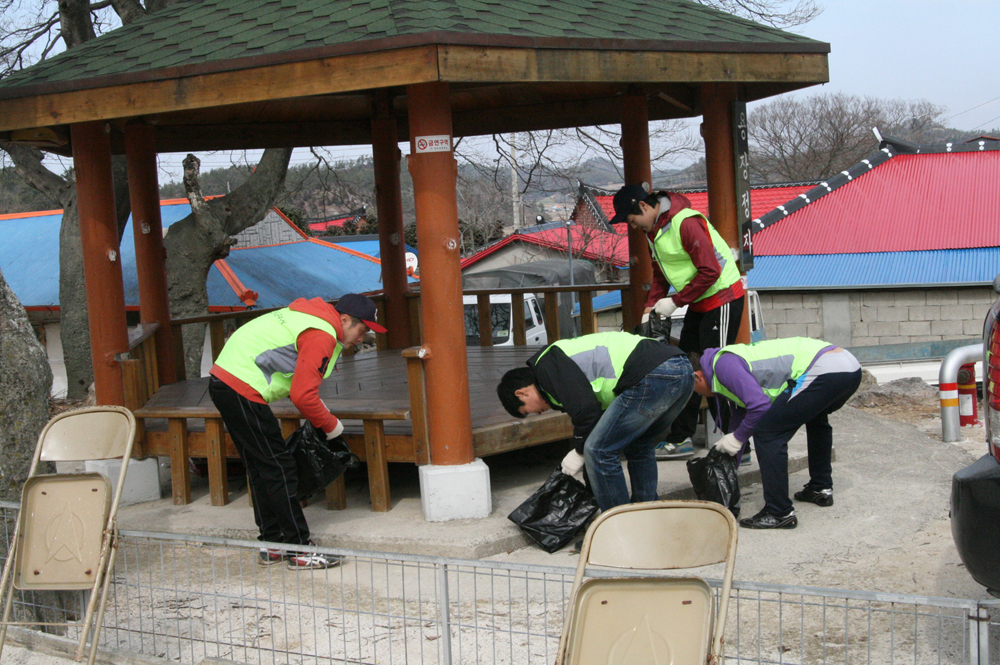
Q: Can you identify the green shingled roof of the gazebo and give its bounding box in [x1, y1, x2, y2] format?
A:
[0, 0, 829, 98]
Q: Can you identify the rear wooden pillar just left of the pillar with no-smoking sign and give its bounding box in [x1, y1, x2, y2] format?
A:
[372, 92, 410, 349]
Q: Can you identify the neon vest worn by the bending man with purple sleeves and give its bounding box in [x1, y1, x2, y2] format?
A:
[712, 337, 833, 407]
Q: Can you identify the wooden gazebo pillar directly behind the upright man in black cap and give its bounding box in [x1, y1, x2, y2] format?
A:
[622, 95, 653, 332]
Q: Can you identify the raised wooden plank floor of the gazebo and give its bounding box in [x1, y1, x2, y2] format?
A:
[140, 346, 572, 461]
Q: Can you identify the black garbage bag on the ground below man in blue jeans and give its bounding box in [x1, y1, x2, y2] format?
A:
[507, 467, 597, 554]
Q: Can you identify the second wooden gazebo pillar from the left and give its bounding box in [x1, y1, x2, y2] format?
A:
[125, 124, 177, 385]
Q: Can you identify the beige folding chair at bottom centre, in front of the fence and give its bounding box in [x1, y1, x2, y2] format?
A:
[556, 501, 737, 665]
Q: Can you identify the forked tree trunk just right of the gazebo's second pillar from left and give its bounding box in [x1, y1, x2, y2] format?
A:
[163, 148, 292, 378]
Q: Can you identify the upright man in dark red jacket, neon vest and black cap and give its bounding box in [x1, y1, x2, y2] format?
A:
[611, 185, 744, 459]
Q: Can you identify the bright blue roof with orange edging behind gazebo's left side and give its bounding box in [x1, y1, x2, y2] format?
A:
[0, 203, 398, 308]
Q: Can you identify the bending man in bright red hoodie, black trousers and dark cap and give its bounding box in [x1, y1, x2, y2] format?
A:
[208, 293, 385, 570]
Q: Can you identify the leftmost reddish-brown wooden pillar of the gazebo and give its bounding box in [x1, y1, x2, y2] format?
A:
[70, 122, 128, 406]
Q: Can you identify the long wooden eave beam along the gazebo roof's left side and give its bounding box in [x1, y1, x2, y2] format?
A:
[0, 45, 439, 131]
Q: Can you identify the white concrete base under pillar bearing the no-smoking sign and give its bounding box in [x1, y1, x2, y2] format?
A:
[420, 458, 493, 522]
